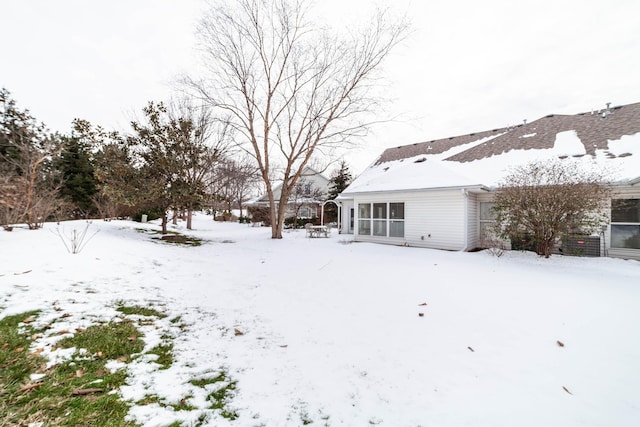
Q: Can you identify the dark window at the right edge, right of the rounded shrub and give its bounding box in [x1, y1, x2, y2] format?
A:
[611, 199, 640, 249]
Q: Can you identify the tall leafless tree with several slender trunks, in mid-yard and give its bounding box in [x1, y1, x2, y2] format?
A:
[186, 0, 408, 239]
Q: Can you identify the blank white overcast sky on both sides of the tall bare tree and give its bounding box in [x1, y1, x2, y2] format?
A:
[0, 0, 640, 173]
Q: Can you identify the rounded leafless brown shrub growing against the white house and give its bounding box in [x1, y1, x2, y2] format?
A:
[493, 161, 611, 258]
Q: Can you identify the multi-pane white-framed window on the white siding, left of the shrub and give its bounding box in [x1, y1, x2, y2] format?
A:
[358, 203, 404, 237]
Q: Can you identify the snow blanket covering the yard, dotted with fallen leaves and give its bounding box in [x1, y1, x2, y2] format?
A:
[0, 216, 640, 427]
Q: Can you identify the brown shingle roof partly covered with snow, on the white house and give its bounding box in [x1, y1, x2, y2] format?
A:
[342, 103, 640, 195]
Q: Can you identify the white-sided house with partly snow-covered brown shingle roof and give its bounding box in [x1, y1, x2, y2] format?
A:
[336, 103, 640, 259]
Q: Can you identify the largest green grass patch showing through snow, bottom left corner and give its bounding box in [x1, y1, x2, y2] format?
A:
[0, 312, 144, 427]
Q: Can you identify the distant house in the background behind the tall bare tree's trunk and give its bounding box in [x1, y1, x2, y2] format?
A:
[247, 167, 329, 219]
